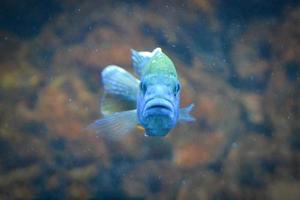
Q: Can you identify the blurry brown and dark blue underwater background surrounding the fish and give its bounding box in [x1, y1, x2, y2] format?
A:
[0, 0, 300, 200]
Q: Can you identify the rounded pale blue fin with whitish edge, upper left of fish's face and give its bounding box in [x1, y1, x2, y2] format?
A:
[101, 65, 140, 101]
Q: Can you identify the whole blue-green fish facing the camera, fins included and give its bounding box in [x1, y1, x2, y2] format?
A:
[87, 47, 195, 138]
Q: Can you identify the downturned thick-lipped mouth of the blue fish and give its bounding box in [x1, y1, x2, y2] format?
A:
[144, 98, 173, 115]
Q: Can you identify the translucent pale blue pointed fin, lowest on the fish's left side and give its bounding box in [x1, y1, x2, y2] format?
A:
[86, 110, 138, 139]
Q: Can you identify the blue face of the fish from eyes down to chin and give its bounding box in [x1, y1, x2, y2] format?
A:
[137, 80, 180, 136]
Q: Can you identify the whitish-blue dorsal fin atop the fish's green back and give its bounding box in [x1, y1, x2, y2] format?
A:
[131, 48, 161, 76]
